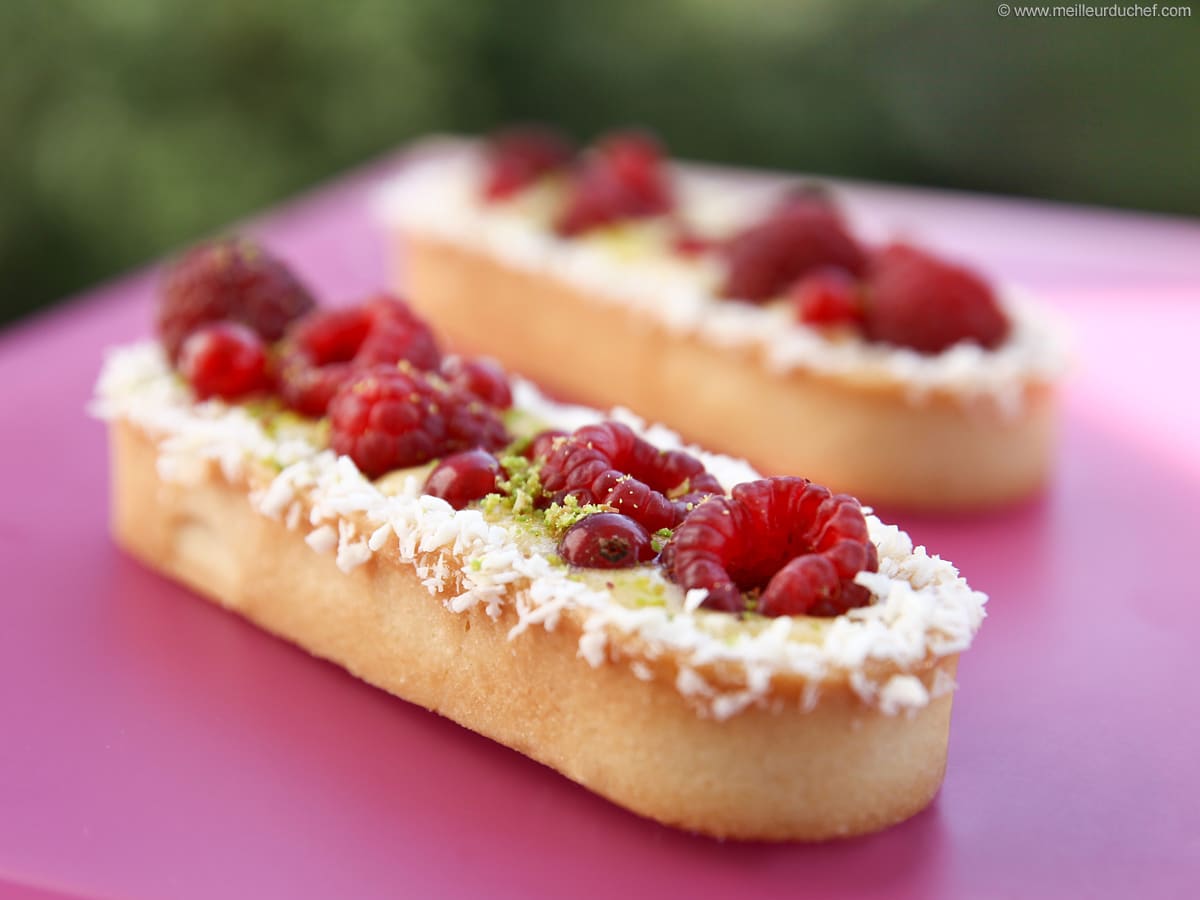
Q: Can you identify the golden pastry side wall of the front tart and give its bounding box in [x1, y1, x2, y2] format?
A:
[110, 421, 958, 840]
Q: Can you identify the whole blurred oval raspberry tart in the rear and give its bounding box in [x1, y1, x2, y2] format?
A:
[379, 128, 1063, 509]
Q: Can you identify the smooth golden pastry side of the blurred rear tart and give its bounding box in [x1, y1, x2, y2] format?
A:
[394, 234, 1055, 510]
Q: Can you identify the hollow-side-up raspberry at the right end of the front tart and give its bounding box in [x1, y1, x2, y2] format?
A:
[664, 478, 878, 616]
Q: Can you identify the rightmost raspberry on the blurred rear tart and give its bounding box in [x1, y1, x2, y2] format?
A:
[866, 244, 1009, 353]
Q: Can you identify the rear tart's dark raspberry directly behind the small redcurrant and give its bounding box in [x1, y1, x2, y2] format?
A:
[721, 200, 866, 302]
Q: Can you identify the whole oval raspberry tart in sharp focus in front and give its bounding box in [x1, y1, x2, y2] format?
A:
[95, 240, 985, 840]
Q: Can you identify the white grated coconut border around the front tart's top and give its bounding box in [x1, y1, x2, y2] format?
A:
[92, 342, 986, 719]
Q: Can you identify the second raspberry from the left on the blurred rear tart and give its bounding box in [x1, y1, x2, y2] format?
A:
[557, 132, 674, 236]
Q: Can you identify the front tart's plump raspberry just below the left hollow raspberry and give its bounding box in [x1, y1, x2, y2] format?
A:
[329, 365, 509, 478]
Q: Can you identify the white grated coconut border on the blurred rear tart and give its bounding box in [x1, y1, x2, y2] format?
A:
[376, 142, 1067, 414]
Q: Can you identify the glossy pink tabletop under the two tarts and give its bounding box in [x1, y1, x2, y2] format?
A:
[0, 154, 1200, 898]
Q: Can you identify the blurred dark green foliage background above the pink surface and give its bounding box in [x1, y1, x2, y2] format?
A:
[0, 0, 1200, 320]
